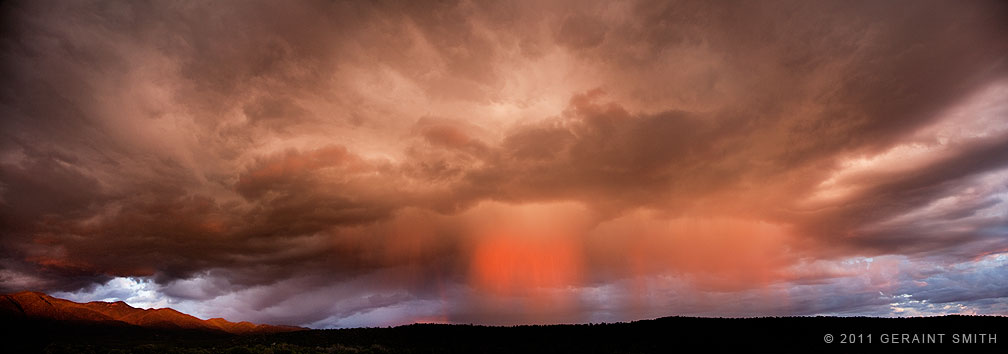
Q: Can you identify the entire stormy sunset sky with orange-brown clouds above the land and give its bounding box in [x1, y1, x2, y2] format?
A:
[0, 0, 1008, 328]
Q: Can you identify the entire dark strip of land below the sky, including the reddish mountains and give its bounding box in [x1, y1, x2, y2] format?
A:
[0, 292, 1008, 353]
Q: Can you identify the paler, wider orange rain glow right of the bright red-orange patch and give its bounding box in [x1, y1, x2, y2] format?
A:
[589, 211, 794, 290]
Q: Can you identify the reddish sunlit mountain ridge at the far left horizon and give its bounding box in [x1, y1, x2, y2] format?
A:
[0, 291, 304, 334]
